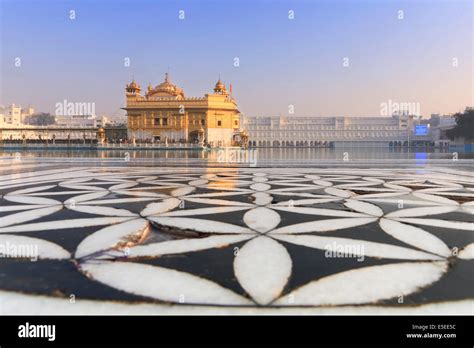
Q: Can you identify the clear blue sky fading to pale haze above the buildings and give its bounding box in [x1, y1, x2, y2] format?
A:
[0, 0, 474, 117]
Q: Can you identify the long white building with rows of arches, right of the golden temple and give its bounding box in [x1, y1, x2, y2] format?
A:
[242, 115, 447, 147]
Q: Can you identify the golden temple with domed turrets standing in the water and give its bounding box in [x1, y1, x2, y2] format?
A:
[124, 74, 240, 146]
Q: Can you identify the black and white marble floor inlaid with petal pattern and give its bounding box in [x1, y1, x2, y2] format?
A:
[0, 163, 474, 314]
